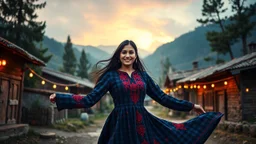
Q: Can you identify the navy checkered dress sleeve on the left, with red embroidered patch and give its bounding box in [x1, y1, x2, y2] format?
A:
[55, 72, 110, 111]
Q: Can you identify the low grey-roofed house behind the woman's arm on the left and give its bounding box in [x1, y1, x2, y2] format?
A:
[22, 62, 110, 125]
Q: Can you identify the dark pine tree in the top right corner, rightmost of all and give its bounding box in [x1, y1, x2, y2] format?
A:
[228, 0, 256, 55]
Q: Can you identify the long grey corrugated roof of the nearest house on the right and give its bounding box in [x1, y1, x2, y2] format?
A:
[177, 52, 256, 83]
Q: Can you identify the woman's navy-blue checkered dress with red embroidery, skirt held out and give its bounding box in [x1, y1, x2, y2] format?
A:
[56, 70, 223, 144]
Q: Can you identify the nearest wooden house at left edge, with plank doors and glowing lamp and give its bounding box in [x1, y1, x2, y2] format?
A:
[0, 37, 45, 139]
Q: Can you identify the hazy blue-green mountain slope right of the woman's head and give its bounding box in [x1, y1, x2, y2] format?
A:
[144, 17, 256, 77]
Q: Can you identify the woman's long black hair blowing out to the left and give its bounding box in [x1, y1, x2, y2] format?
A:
[93, 40, 145, 82]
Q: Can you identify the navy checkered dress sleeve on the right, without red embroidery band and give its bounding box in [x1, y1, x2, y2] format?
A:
[144, 72, 194, 111]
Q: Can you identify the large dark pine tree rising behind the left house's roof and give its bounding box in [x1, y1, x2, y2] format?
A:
[0, 0, 52, 87]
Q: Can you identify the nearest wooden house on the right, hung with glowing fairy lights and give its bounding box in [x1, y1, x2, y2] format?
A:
[177, 52, 256, 122]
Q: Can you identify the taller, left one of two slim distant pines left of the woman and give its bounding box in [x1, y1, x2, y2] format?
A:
[61, 36, 76, 75]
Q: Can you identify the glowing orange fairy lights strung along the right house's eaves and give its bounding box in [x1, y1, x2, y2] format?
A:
[164, 77, 250, 93]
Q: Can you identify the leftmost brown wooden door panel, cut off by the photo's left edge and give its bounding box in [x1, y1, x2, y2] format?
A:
[0, 79, 10, 124]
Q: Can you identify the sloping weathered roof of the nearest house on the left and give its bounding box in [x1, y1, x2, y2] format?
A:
[0, 37, 46, 66]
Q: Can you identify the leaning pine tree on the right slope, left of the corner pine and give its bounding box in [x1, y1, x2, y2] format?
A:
[197, 0, 234, 59]
